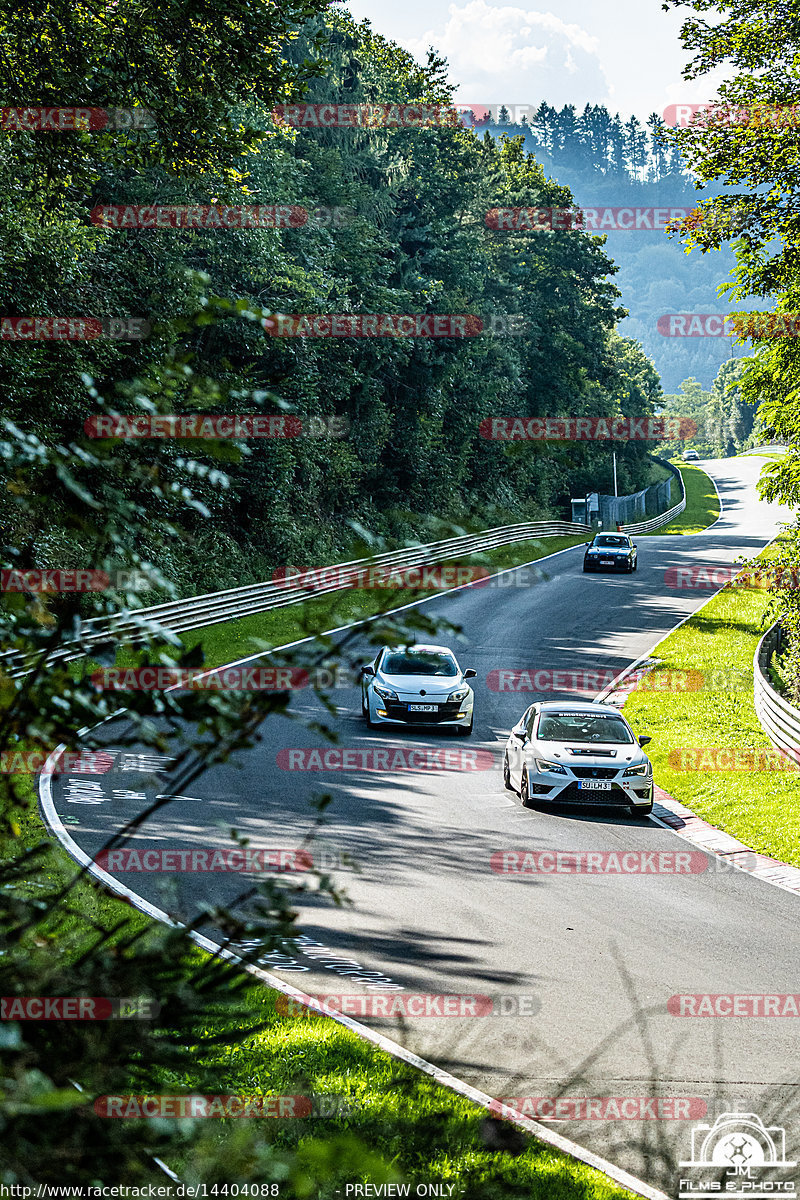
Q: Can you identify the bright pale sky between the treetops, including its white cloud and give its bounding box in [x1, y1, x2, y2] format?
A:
[343, 0, 717, 120]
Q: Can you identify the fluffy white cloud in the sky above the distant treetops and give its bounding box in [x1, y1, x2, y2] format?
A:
[405, 0, 612, 107]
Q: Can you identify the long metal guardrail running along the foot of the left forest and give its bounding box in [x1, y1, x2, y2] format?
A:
[0, 521, 591, 677]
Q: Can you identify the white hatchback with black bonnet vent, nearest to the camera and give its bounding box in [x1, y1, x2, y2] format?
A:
[503, 700, 652, 815]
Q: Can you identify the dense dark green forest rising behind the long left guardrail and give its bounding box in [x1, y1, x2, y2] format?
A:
[0, 13, 660, 593]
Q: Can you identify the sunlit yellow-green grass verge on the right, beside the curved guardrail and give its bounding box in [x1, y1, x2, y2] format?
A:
[625, 544, 800, 866]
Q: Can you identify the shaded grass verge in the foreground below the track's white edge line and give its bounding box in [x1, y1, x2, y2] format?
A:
[155, 988, 631, 1200]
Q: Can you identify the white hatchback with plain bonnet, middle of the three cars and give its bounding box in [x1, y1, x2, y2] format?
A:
[361, 646, 475, 737]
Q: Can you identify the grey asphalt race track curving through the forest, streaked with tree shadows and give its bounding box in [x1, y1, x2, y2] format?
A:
[45, 457, 800, 1193]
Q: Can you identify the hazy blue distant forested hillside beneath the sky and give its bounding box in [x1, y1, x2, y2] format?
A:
[465, 102, 751, 392]
